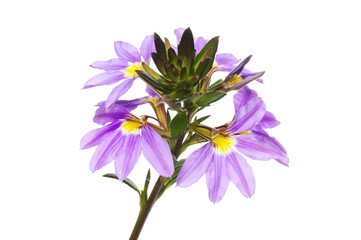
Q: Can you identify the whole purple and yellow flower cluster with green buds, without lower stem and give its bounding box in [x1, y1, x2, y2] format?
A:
[81, 28, 288, 202]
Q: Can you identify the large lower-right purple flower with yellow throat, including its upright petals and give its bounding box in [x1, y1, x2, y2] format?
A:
[177, 87, 289, 202]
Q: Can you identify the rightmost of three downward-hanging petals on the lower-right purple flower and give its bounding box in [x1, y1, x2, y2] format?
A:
[226, 152, 256, 198]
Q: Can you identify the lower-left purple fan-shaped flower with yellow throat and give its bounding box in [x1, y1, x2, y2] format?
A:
[80, 103, 174, 181]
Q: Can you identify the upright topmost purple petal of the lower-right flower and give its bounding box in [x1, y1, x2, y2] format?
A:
[229, 87, 266, 133]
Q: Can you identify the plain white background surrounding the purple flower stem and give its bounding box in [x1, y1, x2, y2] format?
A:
[0, 0, 361, 240]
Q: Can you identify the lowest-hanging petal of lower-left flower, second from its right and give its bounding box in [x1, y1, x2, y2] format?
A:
[114, 134, 142, 181]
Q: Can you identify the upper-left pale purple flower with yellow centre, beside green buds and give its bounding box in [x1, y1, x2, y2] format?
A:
[84, 35, 155, 109]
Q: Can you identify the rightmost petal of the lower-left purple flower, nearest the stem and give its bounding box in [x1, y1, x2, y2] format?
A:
[142, 125, 174, 177]
